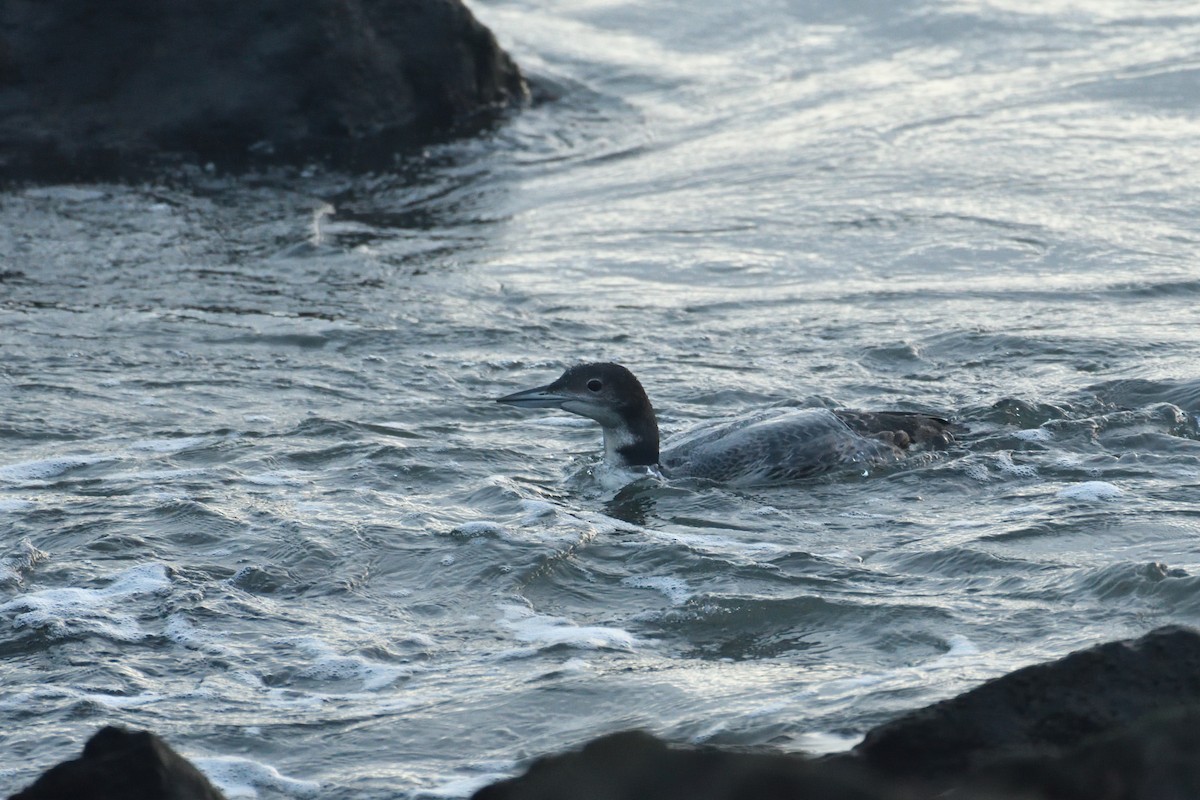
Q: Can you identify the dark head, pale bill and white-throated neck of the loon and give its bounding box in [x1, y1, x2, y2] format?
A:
[496, 363, 659, 467]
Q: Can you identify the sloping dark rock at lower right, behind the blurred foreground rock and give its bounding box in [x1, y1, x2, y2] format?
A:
[853, 626, 1200, 782]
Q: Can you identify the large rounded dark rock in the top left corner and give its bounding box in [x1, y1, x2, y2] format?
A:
[0, 0, 528, 178]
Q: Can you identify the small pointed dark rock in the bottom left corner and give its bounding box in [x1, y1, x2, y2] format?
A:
[10, 727, 223, 800]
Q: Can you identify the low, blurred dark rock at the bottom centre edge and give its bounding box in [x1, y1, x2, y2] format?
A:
[473, 732, 908, 800]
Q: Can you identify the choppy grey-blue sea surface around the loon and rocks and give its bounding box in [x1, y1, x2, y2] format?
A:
[0, 0, 1200, 799]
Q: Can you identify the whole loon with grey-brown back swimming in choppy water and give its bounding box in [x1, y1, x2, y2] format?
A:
[496, 363, 953, 485]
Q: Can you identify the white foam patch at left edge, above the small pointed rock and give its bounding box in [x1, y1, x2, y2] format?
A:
[0, 564, 170, 642]
